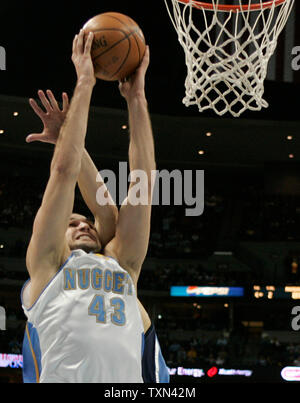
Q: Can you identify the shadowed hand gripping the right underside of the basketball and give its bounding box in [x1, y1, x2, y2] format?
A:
[119, 46, 150, 102]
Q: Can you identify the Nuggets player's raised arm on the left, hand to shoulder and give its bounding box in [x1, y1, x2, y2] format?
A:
[26, 32, 96, 288]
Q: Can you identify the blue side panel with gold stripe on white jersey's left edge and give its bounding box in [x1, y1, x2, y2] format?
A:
[22, 322, 42, 383]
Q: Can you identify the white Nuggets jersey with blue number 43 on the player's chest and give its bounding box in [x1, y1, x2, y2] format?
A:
[21, 250, 144, 383]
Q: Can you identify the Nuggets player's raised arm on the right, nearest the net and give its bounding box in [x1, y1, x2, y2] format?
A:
[106, 48, 156, 283]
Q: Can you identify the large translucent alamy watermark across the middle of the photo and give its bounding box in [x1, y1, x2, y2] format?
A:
[96, 162, 204, 217]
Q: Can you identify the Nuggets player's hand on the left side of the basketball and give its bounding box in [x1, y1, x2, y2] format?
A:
[72, 29, 96, 85]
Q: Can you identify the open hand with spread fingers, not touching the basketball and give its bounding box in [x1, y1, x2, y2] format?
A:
[26, 90, 69, 144]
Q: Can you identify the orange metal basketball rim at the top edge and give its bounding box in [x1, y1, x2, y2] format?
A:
[177, 0, 287, 13]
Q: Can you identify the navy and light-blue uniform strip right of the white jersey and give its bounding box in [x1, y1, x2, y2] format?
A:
[142, 324, 170, 383]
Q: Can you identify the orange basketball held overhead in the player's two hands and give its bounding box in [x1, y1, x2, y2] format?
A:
[83, 12, 146, 81]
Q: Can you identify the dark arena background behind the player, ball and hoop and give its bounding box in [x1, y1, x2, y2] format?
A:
[0, 0, 300, 383]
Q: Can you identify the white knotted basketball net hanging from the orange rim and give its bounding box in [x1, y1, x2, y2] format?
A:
[165, 0, 294, 117]
